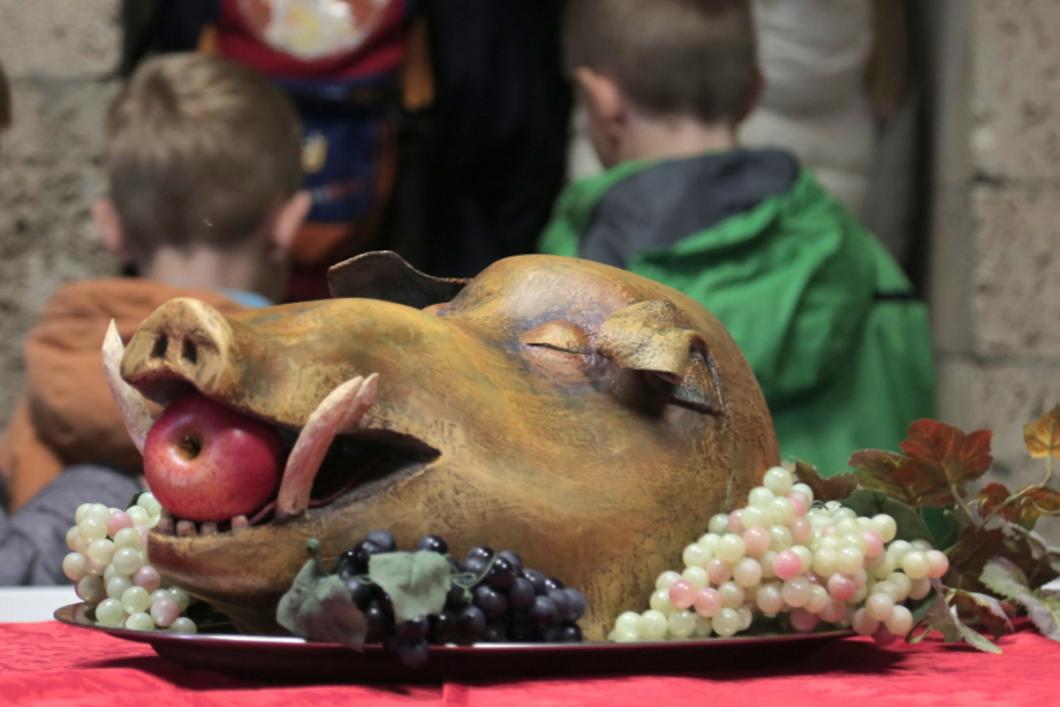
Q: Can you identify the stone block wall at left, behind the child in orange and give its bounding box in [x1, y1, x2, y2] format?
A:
[0, 0, 120, 423]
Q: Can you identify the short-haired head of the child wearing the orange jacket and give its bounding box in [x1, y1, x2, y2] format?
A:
[93, 53, 308, 296]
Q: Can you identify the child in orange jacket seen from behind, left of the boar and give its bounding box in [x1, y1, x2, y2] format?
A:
[0, 54, 310, 584]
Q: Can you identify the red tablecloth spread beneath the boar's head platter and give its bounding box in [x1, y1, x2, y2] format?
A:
[0, 622, 1060, 707]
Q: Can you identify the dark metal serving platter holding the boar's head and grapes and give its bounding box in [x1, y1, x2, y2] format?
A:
[55, 603, 852, 683]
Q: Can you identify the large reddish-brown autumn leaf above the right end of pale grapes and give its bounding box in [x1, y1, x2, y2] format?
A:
[891, 420, 993, 507]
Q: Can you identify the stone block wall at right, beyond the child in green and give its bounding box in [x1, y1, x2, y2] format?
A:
[931, 0, 1060, 537]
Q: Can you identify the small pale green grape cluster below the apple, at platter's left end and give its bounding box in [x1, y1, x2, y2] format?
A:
[63, 492, 197, 633]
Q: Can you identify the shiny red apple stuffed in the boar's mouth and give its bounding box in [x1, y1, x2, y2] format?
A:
[143, 393, 282, 520]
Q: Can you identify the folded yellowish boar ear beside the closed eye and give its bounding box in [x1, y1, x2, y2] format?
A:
[597, 300, 722, 412]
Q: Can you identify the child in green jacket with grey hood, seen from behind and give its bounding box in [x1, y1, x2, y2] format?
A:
[540, 0, 935, 474]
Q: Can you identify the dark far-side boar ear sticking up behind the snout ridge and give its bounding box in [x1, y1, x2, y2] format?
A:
[328, 250, 467, 310]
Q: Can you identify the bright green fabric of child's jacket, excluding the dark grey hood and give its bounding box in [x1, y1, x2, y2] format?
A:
[538, 155, 935, 475]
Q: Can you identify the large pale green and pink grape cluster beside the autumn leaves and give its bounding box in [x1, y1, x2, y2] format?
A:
[608, 466, 949, 642]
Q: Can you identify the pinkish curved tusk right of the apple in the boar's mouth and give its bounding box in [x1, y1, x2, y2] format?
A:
[276, 373, 379, 518]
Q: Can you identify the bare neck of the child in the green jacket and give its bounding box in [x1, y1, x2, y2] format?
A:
[618, 112, 737, 162]
